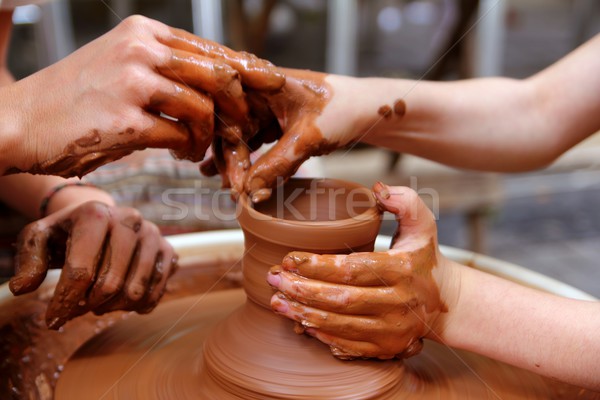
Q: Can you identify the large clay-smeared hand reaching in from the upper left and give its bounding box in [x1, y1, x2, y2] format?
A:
[0, 16, 285, 177]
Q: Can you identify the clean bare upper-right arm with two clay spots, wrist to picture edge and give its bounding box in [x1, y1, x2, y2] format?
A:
[332, 30, 600, 172]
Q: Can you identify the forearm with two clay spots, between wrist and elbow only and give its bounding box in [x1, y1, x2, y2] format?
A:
[328, 77, 559, 171]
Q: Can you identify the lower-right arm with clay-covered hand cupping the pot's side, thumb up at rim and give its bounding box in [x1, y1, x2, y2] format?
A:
[267, 184, 600, 390]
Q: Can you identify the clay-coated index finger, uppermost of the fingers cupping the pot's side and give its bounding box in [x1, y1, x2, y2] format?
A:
[281, 251, 407, 286]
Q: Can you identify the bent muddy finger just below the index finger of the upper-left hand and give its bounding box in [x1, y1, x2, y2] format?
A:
[158, 49, 248, 121]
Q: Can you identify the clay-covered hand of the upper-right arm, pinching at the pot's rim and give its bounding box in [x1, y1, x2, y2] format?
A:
[203, 69, 354, 202]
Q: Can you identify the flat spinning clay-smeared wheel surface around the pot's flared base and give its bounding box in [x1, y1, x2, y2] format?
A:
[55, 290, 581, 400]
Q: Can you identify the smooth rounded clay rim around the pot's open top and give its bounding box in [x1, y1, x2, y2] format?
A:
[238, 178, 382, 252]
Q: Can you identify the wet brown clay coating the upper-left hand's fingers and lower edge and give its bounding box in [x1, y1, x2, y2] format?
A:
[6, 31, 285, 180]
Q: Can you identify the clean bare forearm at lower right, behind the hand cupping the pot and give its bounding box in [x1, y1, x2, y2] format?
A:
[431, 262, 600, 390]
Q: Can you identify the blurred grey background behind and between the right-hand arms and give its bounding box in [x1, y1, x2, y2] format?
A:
[4, 0, 600, 297]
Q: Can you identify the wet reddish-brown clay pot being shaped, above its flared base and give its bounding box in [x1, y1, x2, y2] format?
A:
[238, 179, 381, 308]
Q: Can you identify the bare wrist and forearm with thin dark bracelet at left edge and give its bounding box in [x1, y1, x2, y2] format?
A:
[0, 174, 114, 219]
